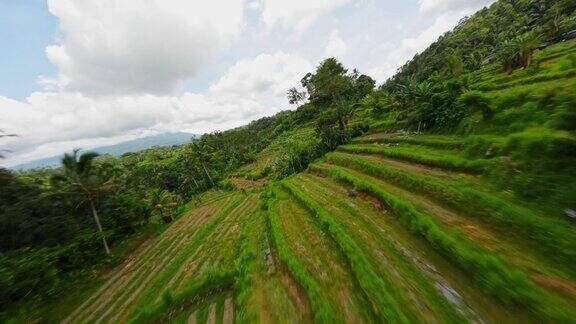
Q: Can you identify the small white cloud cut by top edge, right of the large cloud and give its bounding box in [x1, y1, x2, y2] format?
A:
[262, 0, 351, 32]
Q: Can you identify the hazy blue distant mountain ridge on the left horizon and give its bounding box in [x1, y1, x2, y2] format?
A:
[10, 132, 197, 170]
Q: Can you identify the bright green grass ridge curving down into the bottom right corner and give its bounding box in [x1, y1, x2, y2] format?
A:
[311, 165, 576, 321]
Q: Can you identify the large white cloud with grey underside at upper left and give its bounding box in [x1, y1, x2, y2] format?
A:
[42, 0, 244, 94]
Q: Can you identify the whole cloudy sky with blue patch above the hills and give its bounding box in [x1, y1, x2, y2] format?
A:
[0, 0, 493, 166]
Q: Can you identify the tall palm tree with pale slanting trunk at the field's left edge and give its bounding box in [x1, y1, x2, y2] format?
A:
[52, 149, 111, 254]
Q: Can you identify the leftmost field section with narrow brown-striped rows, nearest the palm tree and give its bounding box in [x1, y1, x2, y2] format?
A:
[64, 194, 251, 323]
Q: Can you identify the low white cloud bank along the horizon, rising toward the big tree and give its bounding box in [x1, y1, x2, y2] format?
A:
[0, 52, 312, 165]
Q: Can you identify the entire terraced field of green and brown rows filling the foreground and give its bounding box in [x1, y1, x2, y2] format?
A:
[64, 138, 576, 323]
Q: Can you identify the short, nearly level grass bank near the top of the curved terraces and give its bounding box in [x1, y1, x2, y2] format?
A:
[338, 144, 494, 173]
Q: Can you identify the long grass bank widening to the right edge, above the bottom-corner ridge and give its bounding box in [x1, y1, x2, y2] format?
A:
[326, 154, 576, 276]
